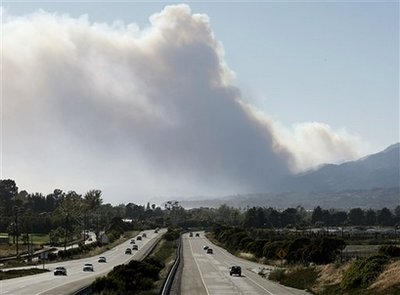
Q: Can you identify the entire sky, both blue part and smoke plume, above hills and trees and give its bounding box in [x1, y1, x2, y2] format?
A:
[1, 1, 399, 203]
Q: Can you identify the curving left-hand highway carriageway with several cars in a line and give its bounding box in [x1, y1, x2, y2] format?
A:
[0, 230, 166, 295]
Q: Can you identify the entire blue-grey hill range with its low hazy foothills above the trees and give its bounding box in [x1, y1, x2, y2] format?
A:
[180, 143, 400, 209]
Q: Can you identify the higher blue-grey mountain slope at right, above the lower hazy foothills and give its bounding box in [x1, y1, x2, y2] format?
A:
[272, 143, 400, 192]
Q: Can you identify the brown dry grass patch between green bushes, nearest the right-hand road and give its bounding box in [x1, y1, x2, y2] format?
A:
[313, 263, 350, 293]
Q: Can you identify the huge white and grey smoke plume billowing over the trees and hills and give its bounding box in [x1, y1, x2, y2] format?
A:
[1, 5, 362, 202]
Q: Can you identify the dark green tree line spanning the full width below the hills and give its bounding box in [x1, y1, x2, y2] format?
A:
[0, 179, 400, 244]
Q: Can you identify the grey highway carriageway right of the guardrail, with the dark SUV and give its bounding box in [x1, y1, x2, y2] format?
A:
[180, 232, 309, 295]
